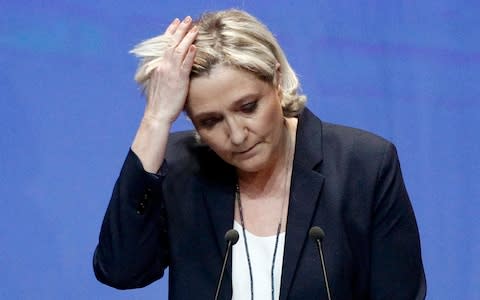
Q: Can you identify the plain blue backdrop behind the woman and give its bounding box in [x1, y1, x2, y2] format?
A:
[0, 0, 480, 299]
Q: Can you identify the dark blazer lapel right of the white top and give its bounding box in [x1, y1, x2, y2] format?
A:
[280, 109, 325, 300]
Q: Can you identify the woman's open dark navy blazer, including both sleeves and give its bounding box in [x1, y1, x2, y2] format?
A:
[94, 109, 426, 300]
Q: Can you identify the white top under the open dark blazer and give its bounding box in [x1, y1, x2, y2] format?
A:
[232, 221, 285, 300]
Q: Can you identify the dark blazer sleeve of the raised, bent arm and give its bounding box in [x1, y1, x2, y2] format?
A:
[93, 149, 169, 289]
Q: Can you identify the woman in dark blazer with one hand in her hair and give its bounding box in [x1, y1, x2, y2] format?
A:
[94, 10, 425, 299]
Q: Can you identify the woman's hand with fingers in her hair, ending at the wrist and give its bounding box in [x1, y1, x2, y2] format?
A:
[144, 17, 198, 124]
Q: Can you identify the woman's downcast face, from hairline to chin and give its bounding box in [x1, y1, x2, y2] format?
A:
[187, 66, 285, 172]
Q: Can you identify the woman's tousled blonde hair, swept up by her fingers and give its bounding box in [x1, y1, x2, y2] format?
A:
[130, 9, 306, 117]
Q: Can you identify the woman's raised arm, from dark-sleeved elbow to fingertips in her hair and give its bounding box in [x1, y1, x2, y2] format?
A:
[93, 17, 197, 289]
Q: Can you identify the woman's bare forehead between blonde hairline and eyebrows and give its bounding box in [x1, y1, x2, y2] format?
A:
[187, 66, 271, 114]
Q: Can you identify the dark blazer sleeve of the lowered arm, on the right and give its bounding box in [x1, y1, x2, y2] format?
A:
[370, 143, 426, 299]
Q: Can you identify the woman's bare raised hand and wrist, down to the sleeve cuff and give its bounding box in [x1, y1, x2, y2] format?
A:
[132, 17, 198, 173]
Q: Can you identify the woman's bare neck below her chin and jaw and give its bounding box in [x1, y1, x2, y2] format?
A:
[237, 118, 297, 196]
